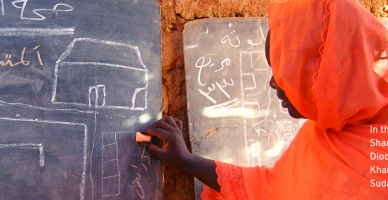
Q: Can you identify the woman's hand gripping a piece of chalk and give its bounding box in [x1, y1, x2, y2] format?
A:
[144, 116, 193, 169]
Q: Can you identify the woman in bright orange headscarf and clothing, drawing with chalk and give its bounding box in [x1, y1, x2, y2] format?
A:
[143, 0, 388, 199]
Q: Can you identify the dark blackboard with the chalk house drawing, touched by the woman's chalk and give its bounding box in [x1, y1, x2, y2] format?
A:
[0, 0, 163, 200]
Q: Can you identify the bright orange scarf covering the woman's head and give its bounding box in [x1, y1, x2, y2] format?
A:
[268, 0, 388, 131]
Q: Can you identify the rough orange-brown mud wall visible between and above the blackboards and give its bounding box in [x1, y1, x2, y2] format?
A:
[157, 0, 388, 200]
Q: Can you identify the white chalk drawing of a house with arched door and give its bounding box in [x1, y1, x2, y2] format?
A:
[51, 38, 148, 110]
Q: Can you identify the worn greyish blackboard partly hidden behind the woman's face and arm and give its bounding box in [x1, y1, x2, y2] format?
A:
[184, 18, 305, 199]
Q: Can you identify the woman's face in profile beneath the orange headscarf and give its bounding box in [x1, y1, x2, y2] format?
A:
[265, 31, 305, 118]
